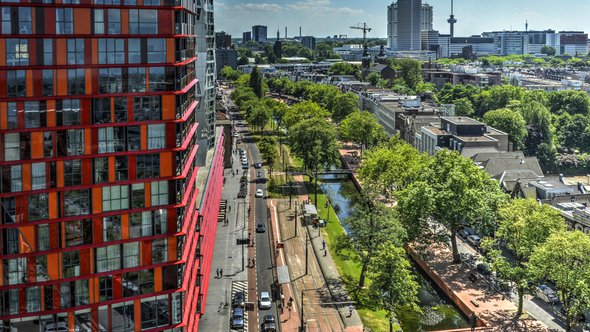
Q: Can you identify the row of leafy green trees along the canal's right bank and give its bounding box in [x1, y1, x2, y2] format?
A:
[354, 137, 590, 331]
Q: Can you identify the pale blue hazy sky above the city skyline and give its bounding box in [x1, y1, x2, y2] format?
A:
[214, 0, 590, 38]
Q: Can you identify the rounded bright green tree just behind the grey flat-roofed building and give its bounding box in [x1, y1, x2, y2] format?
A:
[483, 108, 527, 150]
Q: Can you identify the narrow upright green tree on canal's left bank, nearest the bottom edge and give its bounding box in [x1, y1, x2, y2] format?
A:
[369, 242, 421, 332]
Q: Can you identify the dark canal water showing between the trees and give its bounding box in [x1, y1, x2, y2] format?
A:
[318, 180, 469, 332]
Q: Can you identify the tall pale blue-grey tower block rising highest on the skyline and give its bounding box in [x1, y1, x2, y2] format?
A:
[387, 0, 427, 51]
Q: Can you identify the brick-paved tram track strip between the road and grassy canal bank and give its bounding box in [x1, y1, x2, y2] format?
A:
[270, 176, 363, 332]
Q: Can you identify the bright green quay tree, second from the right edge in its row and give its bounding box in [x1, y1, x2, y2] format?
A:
[482, 199, 565, 317]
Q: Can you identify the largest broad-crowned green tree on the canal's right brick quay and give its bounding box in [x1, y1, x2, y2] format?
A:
[396, 150, 507, 263]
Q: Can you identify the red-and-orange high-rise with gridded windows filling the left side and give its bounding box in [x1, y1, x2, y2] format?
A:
[0, 0, 224, 332]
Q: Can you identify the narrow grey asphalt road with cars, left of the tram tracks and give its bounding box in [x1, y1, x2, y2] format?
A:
[238, 114, 278, 326]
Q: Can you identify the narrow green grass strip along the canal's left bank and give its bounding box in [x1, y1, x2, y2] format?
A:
[304, 182, 399, 331]
